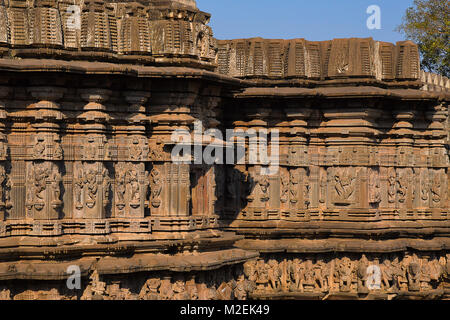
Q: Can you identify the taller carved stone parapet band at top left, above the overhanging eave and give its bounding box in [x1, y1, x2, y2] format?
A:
[0, 0, 216, 63]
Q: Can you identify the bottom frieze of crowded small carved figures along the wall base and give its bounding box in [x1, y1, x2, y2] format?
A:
[0, 252, 450, 300]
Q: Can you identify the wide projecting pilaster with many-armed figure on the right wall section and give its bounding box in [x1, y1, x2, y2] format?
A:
[318, 100, 381, 214]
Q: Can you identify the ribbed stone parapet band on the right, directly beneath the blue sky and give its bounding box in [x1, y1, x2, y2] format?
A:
[217, 38, 420, 80]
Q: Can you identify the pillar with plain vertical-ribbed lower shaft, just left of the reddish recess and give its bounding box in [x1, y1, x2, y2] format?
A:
[148, 80, 199, 217]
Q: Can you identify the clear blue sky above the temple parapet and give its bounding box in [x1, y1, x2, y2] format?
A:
[197, 0, 413, 42]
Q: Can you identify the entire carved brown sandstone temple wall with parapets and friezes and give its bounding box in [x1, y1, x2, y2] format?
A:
[0, 0, 450, 299]
